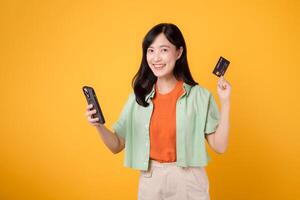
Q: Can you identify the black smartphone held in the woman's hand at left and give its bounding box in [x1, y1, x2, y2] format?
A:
[82, 86, 105, 124]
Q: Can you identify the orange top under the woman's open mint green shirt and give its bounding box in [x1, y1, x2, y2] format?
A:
[150, 81, 184, 162]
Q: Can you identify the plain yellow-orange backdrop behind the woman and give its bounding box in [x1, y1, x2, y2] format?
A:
[0, 0, 300, 200]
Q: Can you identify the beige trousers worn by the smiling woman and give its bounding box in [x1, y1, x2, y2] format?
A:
[138, 160, 210, 200]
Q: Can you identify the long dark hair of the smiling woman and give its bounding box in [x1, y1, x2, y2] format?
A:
[132, 23, 198, 107]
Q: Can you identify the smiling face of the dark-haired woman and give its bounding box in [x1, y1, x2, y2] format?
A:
[147, 33, 183, 78]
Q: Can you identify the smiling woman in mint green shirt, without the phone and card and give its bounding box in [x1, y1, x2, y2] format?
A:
[86, 23, 231, 200]
